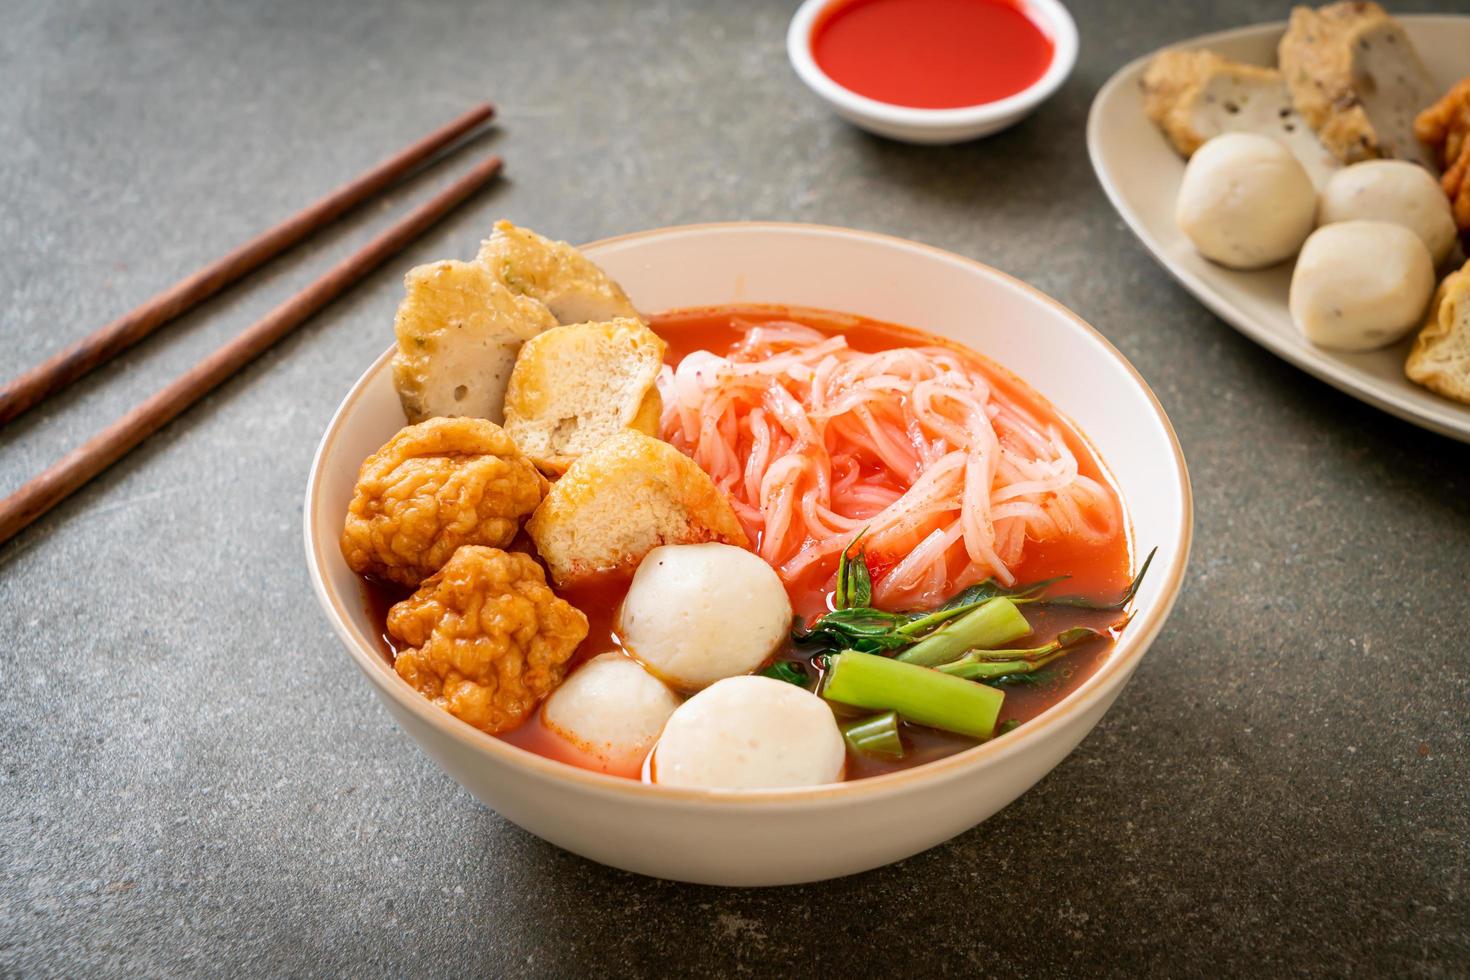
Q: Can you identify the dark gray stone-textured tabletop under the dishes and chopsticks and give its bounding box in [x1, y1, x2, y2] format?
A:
[0, 0, 1470, 977]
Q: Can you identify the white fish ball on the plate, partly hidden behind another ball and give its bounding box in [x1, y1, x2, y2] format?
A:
[1317, 160, 1455, 266]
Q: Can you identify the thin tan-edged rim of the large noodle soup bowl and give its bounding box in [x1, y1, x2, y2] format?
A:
[303, 222, 1194, 808]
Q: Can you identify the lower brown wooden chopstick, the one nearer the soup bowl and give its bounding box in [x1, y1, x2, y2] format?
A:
[0, 156, 501, 544]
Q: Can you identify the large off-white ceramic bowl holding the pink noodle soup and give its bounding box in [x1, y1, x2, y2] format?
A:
[306, 223, 1192, 884]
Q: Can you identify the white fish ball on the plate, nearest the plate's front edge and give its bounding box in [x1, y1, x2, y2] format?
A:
[1289, 222, 1435, 351]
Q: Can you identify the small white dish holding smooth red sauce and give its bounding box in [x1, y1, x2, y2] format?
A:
[786, 0, 1078, 143]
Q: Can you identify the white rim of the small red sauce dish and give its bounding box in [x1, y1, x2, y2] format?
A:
[786, 0, 1079, 129]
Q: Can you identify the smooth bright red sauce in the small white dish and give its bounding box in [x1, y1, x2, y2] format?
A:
[811, 0, 1053, 109]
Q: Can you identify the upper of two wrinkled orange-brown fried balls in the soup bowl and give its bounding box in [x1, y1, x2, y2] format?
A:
[343, 417, 547, 585]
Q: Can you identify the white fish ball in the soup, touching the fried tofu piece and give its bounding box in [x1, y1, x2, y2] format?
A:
[619, 544, 791, 691]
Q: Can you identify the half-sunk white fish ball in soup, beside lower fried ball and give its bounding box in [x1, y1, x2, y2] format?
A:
[541, 652, 679, 771]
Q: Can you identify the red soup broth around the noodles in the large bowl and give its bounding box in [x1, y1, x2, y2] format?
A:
[363, 306, 1130, 779]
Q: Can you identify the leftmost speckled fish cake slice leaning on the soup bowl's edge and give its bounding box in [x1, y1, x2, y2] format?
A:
[392, 262, 556, 422]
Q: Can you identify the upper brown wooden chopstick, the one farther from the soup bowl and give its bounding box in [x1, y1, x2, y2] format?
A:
[0, 103, 495, 426]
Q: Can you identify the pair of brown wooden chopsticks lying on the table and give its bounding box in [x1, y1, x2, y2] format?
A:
[0, 103, 501, 544]
